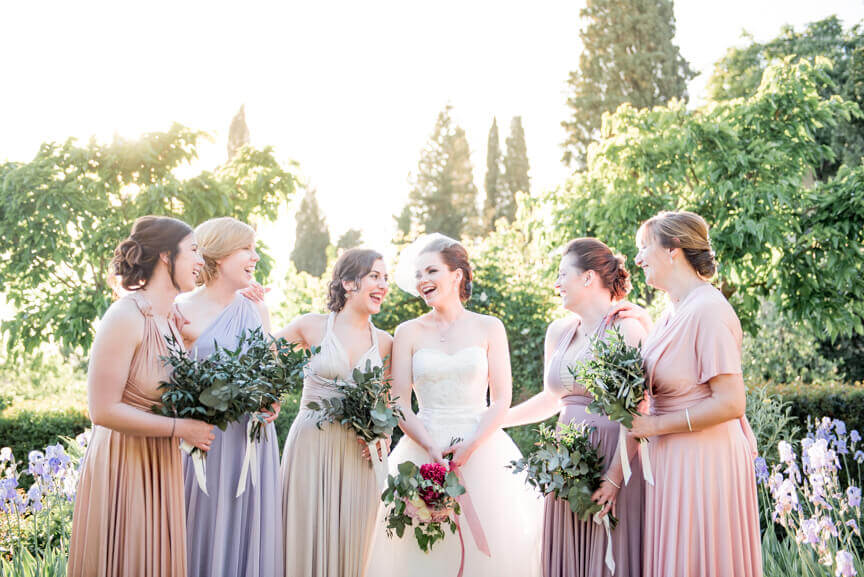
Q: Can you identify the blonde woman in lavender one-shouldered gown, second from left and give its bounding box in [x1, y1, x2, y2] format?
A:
[178, 217, 282, 577]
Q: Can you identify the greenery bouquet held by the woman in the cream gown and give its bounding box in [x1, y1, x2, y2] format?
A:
[307, 360, 403, 488]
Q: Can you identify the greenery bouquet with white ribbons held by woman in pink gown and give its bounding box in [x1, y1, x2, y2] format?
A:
[569, 327, 654, 485]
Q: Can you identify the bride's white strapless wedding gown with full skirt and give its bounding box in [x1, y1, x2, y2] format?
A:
[367, 347, 543, 577]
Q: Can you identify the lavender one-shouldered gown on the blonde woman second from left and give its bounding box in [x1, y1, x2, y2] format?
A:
[183, 295, 282, 577]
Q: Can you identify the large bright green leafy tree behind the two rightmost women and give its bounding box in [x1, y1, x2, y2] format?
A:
[552, 61, 864, 336]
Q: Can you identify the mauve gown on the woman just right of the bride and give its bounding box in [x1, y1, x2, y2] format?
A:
[542, 319, 644, 577]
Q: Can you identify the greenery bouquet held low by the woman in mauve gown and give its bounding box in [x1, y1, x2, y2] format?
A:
[509, 423, 618, 574]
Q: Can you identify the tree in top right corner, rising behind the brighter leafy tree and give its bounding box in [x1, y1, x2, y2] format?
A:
[708, 16, 864, 180]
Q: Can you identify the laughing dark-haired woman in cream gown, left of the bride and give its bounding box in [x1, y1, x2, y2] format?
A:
[275, 249, 393, 577]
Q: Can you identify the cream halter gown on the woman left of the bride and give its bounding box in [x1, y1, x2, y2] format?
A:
[282, 313, 382, 577]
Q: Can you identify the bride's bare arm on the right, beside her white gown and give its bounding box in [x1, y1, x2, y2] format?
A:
[447, 318, 513, 466]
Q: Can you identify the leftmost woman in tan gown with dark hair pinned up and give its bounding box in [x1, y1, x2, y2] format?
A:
[67, 216, 214, 577]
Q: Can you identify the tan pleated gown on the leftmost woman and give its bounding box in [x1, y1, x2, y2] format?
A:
[66, 293, 186, 577]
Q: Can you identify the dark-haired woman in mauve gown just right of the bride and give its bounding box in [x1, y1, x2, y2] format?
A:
[504, 238, 645, 577]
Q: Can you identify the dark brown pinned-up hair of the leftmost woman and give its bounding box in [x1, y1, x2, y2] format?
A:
[111, 216, 192, 291]
